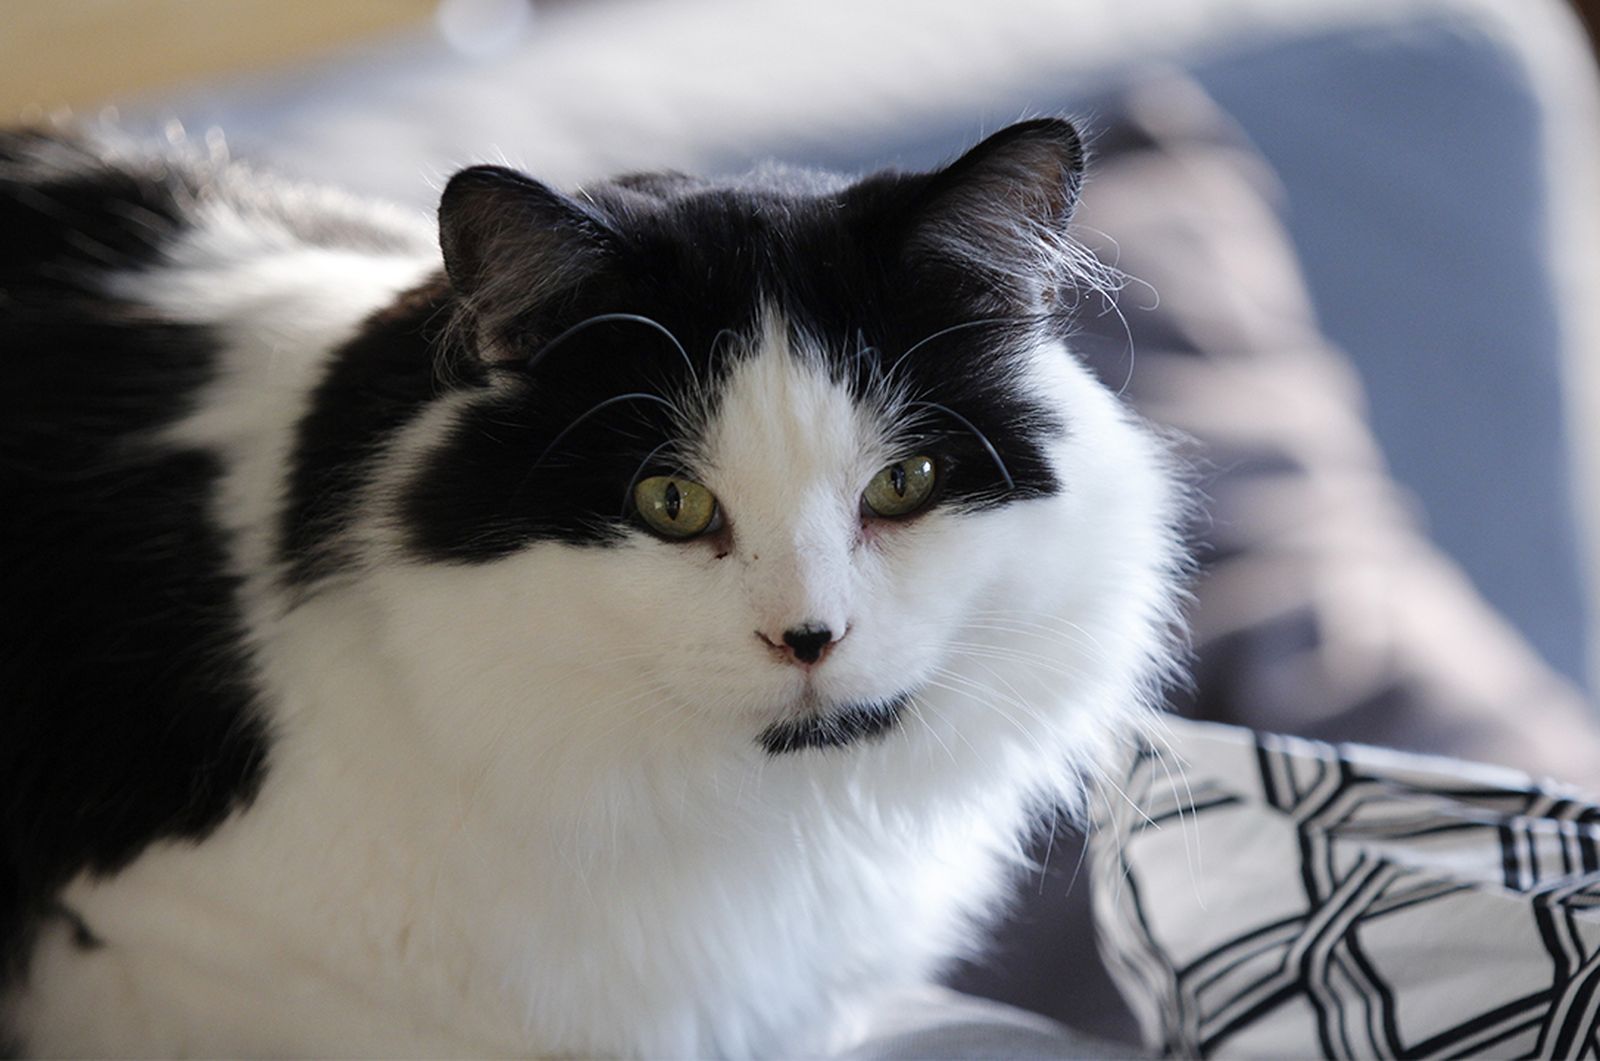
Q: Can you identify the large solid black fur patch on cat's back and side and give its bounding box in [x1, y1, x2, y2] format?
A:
[0, 136, 267, 998]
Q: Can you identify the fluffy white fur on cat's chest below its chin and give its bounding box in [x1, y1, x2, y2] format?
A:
[22, 585, 1043, 1056]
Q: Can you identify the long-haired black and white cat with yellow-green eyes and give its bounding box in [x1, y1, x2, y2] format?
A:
[0, 118, 1182, 1056]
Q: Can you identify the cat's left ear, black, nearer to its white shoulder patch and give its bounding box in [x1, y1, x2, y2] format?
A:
[438, 166, 611, 360]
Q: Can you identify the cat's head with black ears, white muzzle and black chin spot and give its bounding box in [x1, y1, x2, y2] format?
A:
[368, 120, 1174, 800]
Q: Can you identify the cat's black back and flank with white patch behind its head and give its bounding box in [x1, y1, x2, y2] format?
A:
[0, 133, 438, 1004]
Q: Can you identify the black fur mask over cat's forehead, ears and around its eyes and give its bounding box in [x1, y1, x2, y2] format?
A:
[396, 123, 1078, 562]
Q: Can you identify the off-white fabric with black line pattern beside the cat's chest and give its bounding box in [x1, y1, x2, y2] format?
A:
[1091, 720, 1600, 1058]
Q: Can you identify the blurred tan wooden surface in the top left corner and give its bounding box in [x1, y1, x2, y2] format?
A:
[0, 0, 437, 122]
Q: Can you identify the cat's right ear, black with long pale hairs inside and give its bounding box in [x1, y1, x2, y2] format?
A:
[907, 118, 1083, 298]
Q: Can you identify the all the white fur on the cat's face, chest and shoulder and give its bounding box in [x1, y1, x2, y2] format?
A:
[16, 199, 1176, 1056]
